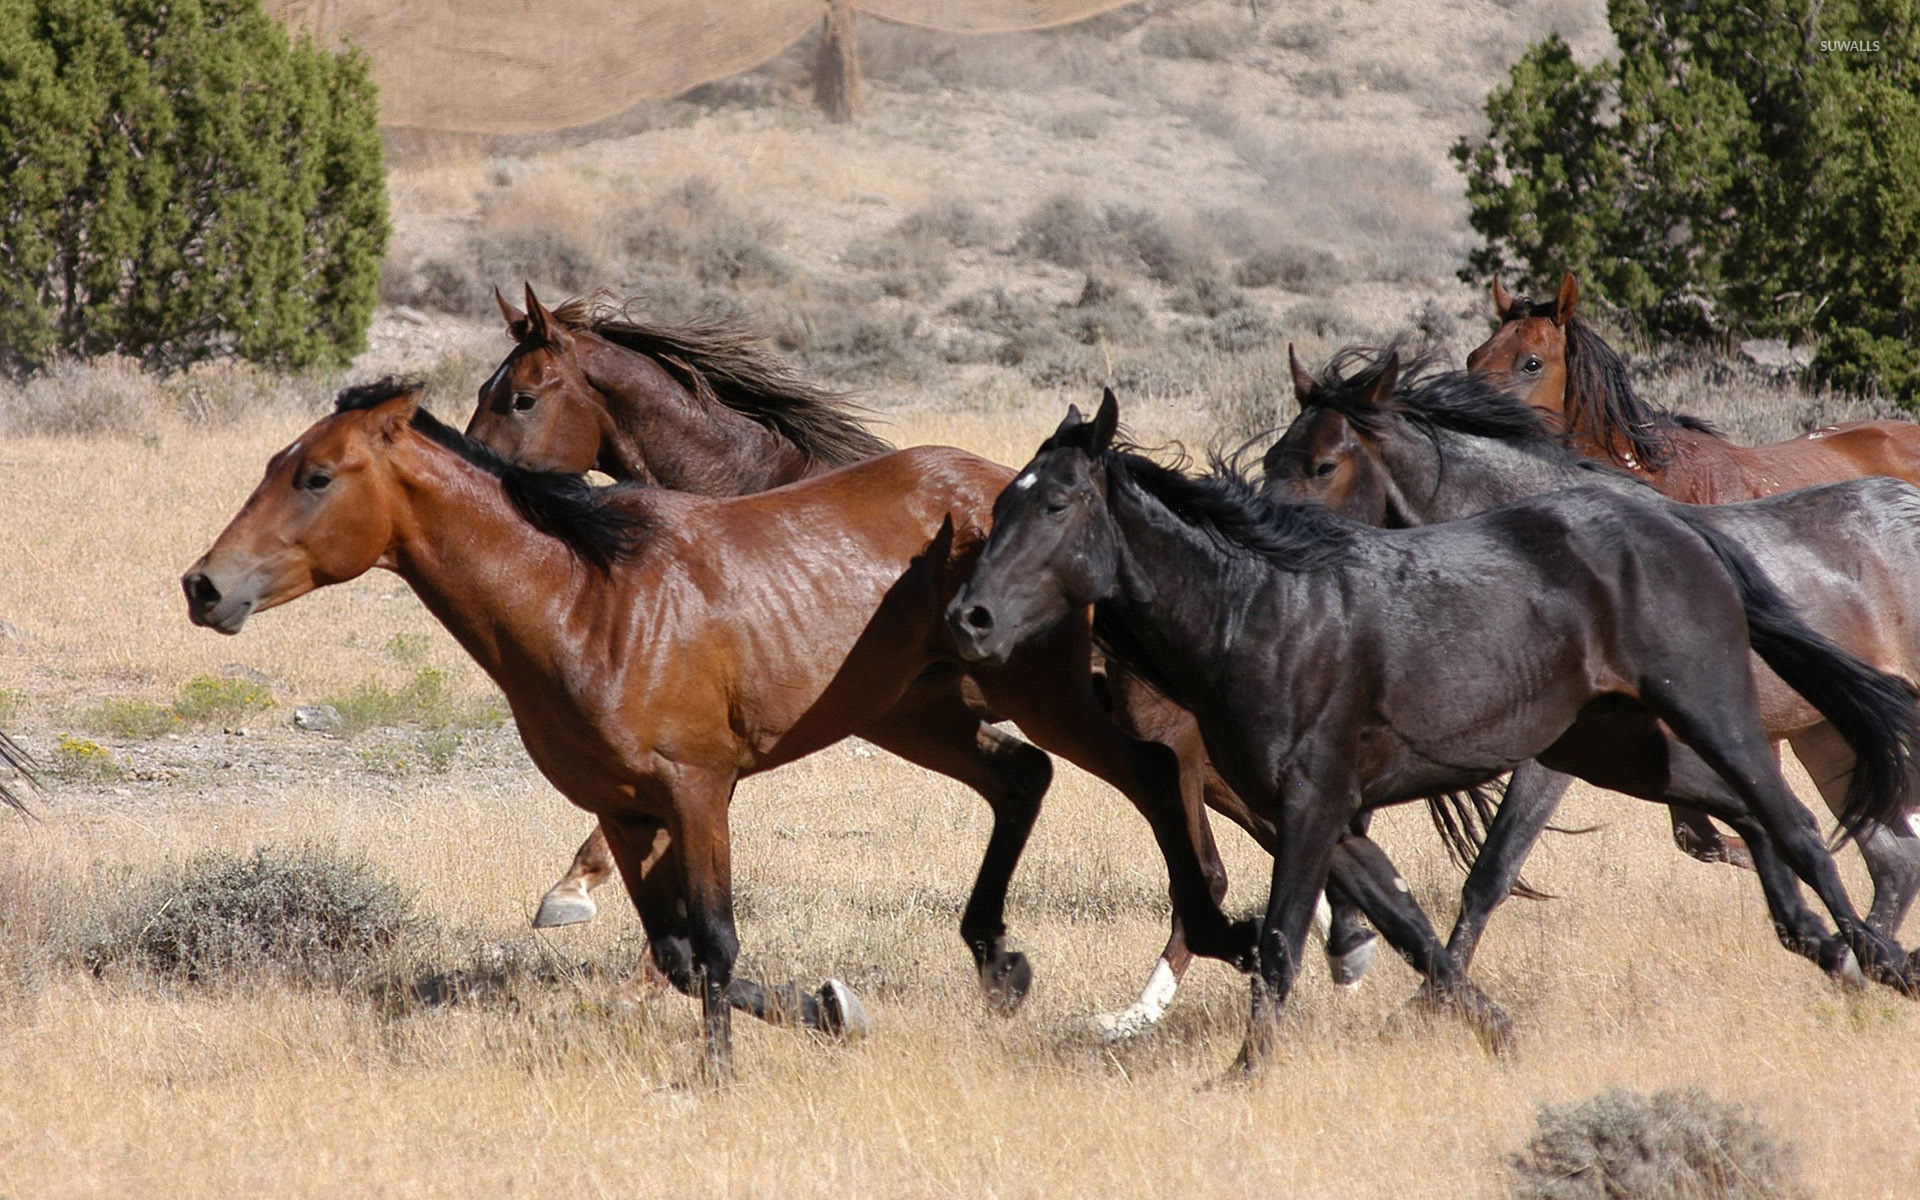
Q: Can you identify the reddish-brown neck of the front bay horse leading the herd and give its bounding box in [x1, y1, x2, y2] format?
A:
[388, 436, 601, 699]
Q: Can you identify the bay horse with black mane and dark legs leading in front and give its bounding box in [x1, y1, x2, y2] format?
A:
[182, 380, 1252, 1075]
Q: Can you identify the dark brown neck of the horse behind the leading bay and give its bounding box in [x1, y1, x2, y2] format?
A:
[582, 336, 816, 495]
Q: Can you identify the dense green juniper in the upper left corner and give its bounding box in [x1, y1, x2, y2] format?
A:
[0, 0, 388, 374]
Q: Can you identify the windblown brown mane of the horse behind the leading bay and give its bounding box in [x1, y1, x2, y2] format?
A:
[553, 292, 893, 467]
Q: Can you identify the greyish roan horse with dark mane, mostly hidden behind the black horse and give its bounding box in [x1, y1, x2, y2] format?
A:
[1261, 349, 1920, 970]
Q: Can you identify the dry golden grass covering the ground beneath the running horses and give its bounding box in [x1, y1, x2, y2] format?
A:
[0, 370, 1920, 1198]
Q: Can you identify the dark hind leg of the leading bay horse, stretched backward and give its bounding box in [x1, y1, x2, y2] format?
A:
[970, 622, 1256, 968]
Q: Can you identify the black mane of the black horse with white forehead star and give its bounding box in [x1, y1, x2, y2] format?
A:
[1102, 445, 1356, 572]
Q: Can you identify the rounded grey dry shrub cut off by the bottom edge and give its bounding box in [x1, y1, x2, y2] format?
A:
[1511, 1089, 1807, 1200]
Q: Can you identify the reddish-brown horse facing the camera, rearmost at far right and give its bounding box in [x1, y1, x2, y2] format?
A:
[1467, 271, 1920, 866]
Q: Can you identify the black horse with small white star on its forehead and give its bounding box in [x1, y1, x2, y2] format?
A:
[947, 394, 1920, 1068]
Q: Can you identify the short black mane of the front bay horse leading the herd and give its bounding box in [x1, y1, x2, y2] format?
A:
[334, 376, 647, 570]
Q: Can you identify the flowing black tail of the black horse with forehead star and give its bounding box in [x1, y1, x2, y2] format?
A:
[1672, 505, 1920, 841]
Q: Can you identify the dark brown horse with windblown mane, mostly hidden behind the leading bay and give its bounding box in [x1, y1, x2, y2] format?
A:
[467, 288, 1505, 1044]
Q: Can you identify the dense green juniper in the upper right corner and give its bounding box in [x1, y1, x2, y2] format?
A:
[1453, 0, 1920, 405]
